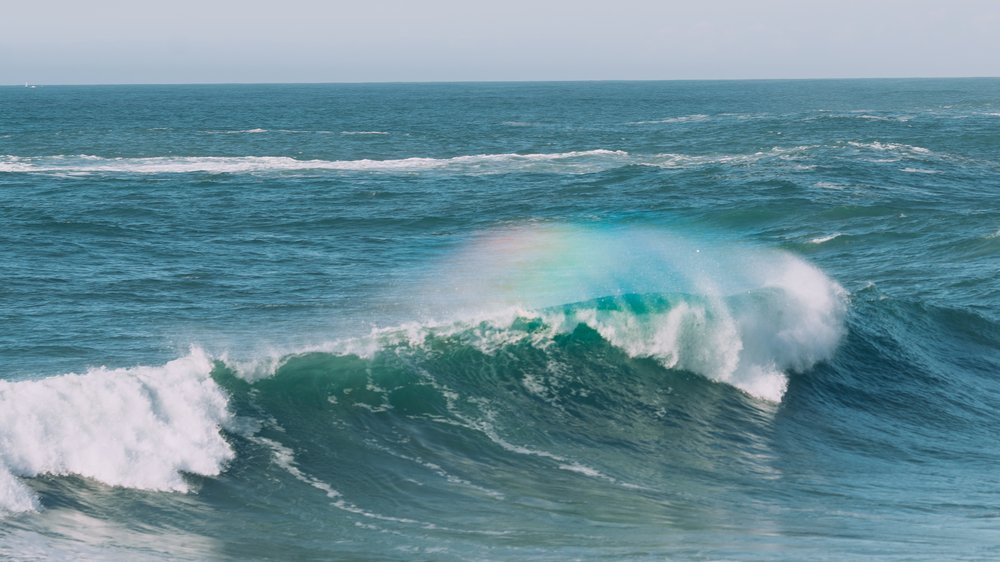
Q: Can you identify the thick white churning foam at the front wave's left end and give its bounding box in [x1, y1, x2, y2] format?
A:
[0, 349, 233, 514]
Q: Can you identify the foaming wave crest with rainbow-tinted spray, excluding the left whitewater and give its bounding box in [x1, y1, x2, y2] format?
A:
[236, 226, 847, 402]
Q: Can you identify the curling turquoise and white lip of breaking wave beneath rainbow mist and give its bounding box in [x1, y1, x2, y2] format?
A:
[540, 272, 845, 402]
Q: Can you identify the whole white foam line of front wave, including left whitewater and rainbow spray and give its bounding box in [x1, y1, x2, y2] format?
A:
[0, 225, 847, 513]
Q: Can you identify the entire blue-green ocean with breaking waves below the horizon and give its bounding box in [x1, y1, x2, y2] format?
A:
[0, 79, 1000, 561]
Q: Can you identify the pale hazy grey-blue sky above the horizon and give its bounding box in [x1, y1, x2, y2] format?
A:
[0, 0, 1000, 84]
